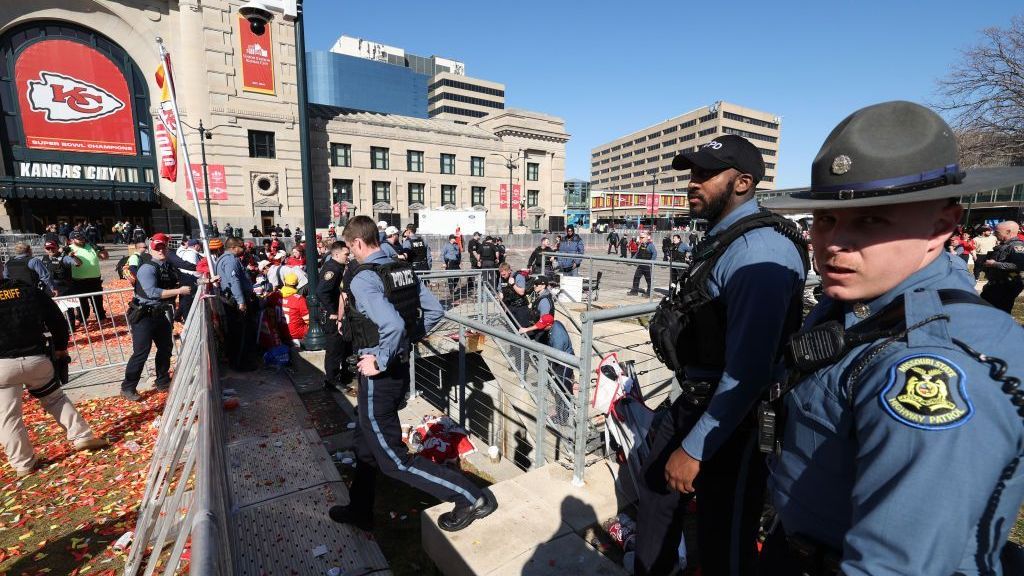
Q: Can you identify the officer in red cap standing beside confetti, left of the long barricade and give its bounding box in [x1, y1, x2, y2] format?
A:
[121, 234, 191, 402]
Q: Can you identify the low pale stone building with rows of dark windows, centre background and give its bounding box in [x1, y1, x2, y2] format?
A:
[310, 106, 569, 235]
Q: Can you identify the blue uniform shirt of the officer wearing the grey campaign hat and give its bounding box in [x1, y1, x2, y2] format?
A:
[769, 253, 1024, 576]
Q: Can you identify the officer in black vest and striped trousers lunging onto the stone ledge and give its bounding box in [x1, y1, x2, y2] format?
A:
[330, 216, 498, 531]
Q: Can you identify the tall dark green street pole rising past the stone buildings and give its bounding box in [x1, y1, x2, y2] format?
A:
[295, 0, 327, 351]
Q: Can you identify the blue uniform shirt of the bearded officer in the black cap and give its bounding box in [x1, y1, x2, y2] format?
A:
[682, 201, 805, 460]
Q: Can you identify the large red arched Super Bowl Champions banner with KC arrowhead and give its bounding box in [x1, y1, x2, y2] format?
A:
[14, 40, 136, 156]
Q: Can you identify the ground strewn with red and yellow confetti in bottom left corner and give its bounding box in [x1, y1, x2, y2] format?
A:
[0, 383, 167, 576]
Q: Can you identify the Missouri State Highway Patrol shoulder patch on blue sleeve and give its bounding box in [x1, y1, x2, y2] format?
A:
[879, 354, 974, 430]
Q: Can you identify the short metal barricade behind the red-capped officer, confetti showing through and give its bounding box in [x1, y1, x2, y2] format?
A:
[53, 288, 140, 375]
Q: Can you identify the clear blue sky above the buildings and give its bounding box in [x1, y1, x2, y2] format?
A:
[305, 0, 1024, 188]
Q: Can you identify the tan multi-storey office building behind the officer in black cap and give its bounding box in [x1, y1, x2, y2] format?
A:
[590, 101, 781, 222]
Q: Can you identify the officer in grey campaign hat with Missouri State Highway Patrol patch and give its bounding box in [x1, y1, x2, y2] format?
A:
[762, 101, 1024, 576]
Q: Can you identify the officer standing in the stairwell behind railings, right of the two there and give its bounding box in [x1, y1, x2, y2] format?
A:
[519, 275, 575, 425]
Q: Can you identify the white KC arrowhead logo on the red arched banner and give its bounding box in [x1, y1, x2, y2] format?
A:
[28, 72, 125, 122]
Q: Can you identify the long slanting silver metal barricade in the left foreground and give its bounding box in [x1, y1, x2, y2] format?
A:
[124, 284, 234, 576]
